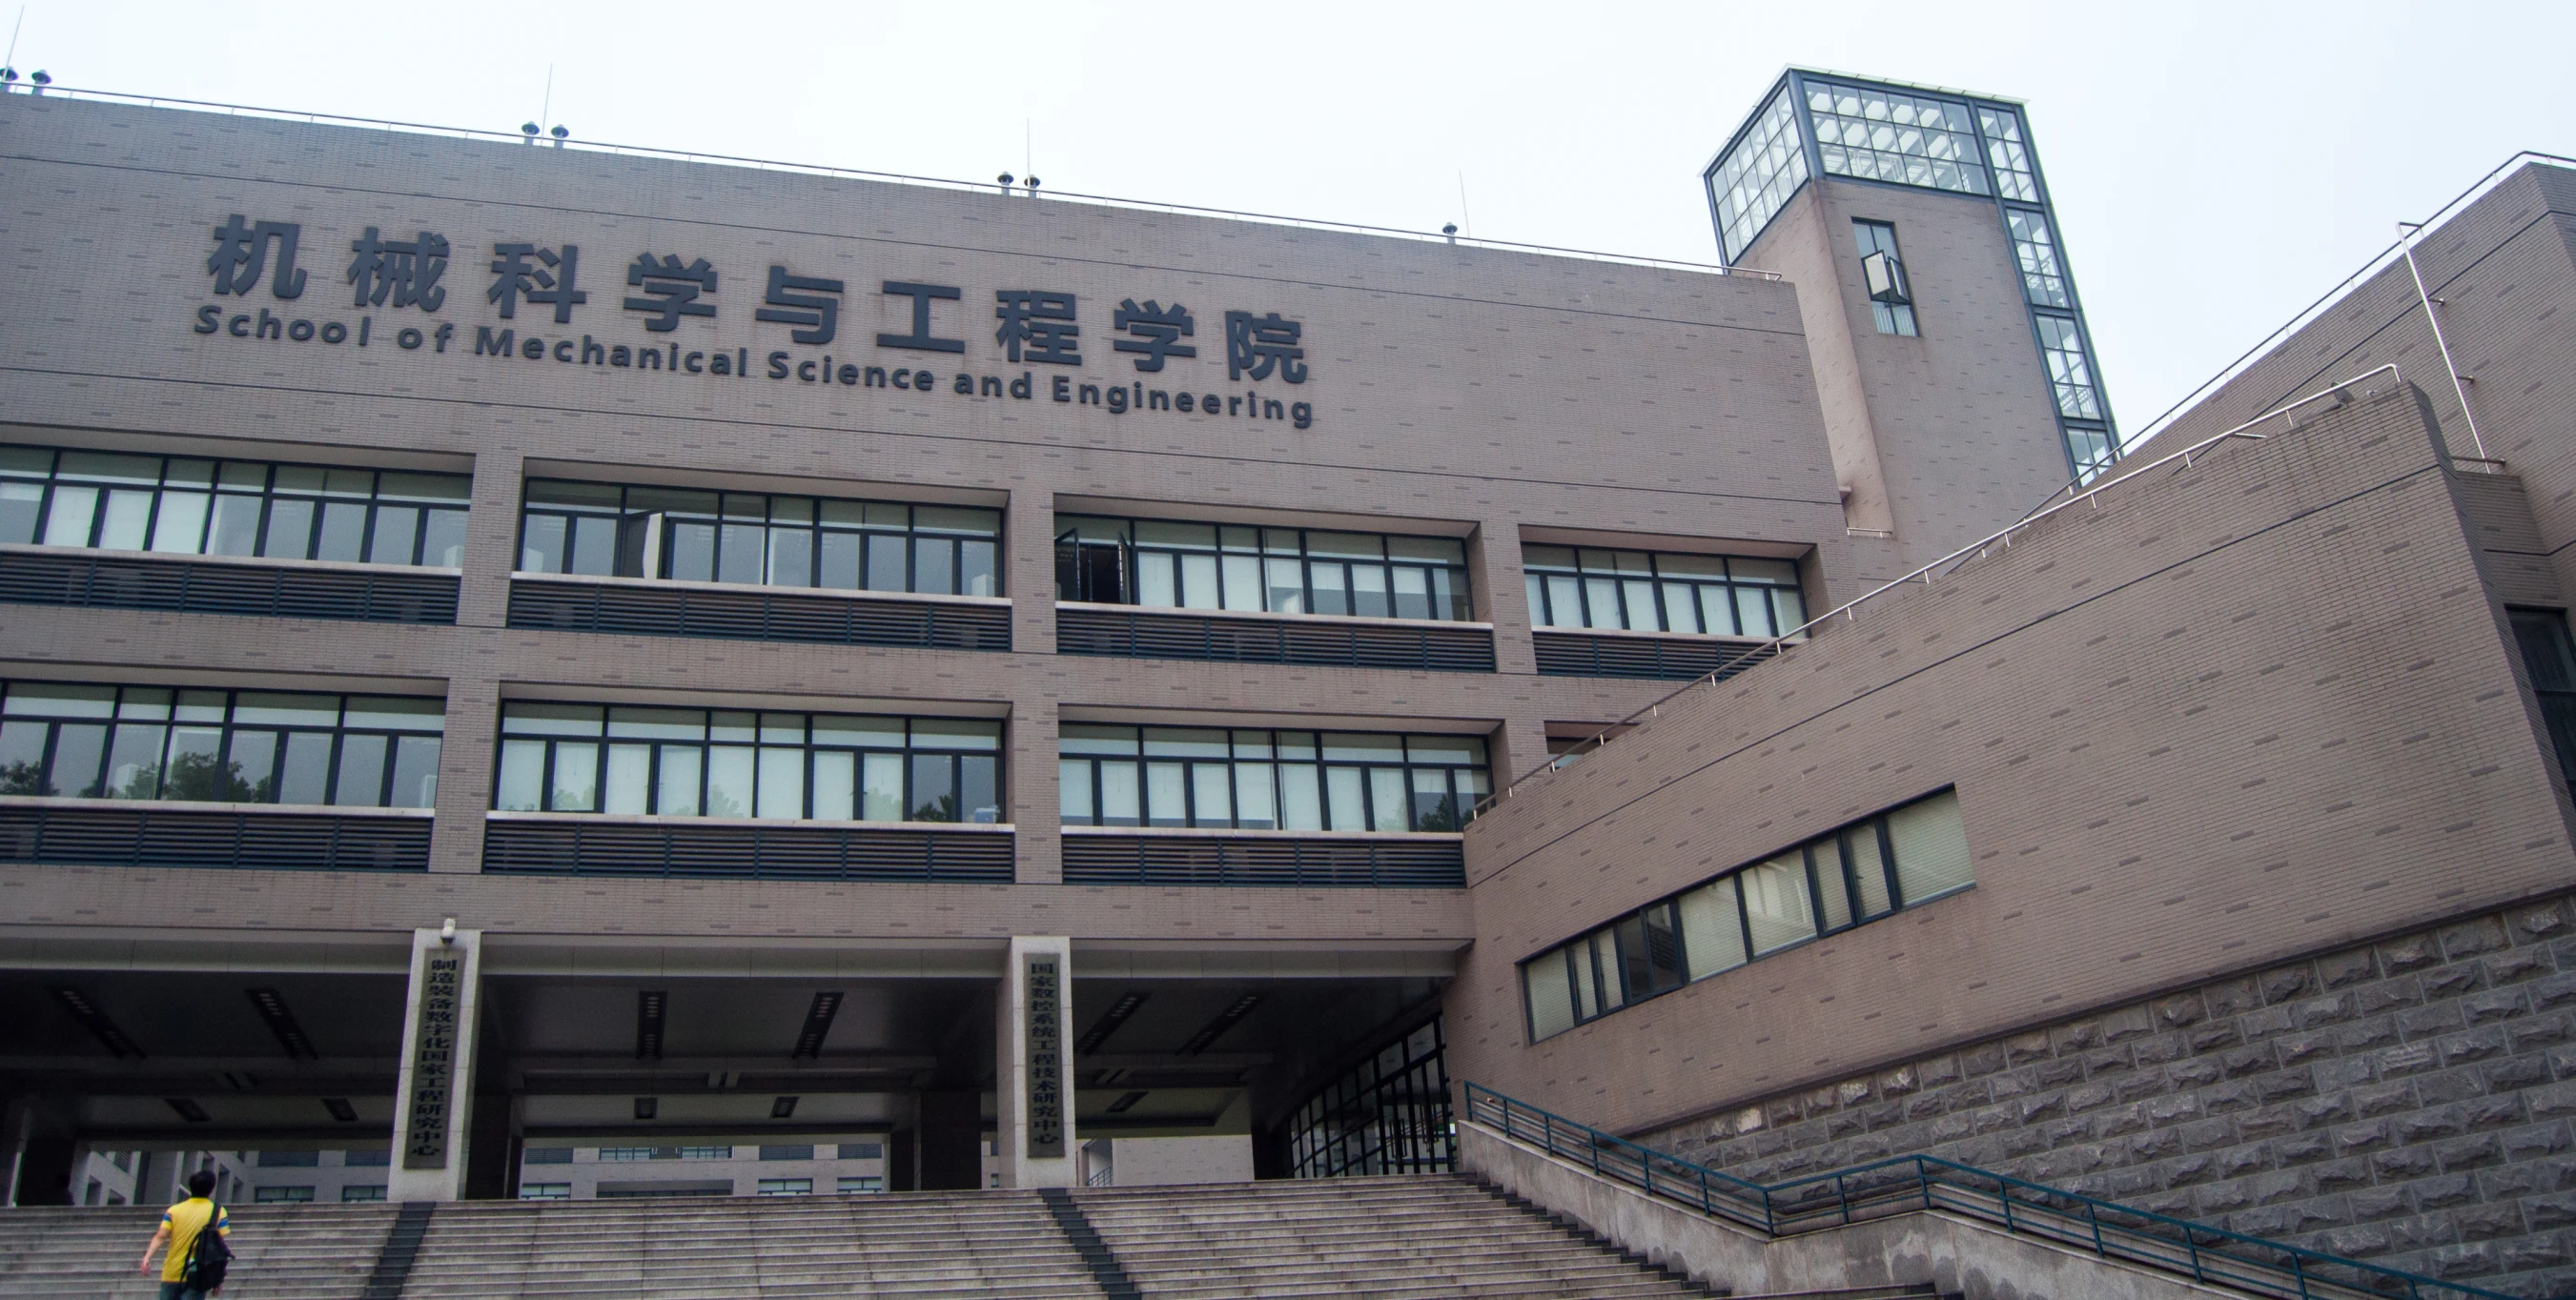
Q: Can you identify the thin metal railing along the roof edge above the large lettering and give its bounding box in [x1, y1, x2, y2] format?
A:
[0, 85, 1780, 280]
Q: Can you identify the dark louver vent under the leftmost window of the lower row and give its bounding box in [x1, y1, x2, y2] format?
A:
[0, 803, 430, 870]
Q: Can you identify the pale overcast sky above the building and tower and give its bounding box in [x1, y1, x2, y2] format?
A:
[14, 0, 2576, 435]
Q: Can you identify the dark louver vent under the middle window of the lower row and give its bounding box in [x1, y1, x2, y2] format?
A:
[484, 816, 1012, 883]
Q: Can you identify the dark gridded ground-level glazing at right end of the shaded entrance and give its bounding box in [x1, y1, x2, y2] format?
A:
[1288, 1020, 1458, 1179]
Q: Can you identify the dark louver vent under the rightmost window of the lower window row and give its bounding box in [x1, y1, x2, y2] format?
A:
[1064, 834, 1465, 888]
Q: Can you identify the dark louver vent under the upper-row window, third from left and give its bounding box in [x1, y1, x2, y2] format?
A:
[1056, 605, 1494, 672]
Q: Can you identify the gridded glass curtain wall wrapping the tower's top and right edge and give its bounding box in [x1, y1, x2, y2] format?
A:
[1703, 70, 2120, 478]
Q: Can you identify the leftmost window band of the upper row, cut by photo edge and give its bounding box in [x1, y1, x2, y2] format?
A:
[0, 445, 471, 569]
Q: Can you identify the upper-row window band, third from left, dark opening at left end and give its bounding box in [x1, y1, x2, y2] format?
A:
[1056, 515, 1471, 620]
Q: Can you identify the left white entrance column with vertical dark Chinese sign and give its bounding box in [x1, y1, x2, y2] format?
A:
[384, 929, 481, 1202]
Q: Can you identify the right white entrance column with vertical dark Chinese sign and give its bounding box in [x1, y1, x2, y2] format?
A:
[994, 934, 1082, 1187]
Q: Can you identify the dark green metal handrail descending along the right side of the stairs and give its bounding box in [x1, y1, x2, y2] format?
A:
[1461, 1084, 2506, 1300]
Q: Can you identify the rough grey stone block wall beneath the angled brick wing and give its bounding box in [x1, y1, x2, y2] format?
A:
[1638, 899, 2576, 1295]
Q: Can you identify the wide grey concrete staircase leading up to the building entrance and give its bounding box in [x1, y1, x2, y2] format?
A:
[0, 1176, 1927, 1300]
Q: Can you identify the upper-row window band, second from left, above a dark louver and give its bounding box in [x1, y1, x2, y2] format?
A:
[518, 478, 1002, 595]
